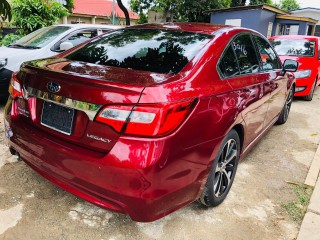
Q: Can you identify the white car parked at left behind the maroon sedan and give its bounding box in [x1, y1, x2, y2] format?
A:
[0, 24, 120, 99]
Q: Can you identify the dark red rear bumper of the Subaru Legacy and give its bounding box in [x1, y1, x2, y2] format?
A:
[5, 97, 221, 222]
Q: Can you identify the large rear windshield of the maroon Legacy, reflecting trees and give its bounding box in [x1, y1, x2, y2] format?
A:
[66, 29, 212, 74]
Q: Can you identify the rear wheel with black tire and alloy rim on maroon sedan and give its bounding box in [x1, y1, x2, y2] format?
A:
[199, 130, 240, 207]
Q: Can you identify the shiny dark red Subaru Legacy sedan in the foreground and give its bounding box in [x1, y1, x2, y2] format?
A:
[5, 23, 297, 222]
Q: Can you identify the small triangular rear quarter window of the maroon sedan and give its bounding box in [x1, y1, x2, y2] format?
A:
[219, 46, 239, 77]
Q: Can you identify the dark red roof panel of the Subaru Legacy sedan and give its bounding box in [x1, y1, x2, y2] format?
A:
[128, 23, 240, 35]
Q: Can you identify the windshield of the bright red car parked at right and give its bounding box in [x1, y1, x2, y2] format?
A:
[271, 39, 316, 57]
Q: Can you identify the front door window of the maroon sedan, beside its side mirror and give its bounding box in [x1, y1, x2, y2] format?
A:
[254, 36, 281, 70]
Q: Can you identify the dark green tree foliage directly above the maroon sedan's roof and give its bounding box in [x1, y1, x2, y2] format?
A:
[130, 0, 231, 22]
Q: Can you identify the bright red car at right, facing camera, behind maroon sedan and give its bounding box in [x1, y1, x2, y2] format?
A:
[270, 35, 320, 101]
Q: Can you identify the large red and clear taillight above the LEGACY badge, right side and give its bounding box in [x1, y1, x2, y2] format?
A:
[96, 100, 194, 137]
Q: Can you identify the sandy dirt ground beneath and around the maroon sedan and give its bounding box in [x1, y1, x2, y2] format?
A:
[0, 89, 320, 240]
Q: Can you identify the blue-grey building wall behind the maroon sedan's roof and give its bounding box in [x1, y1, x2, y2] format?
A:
[210, 9, 275, 36]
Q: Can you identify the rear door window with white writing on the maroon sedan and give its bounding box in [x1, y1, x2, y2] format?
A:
[232, 35, 259, 74]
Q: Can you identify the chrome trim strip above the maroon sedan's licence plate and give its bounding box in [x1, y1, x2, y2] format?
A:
[23, 86, 102, 121]
